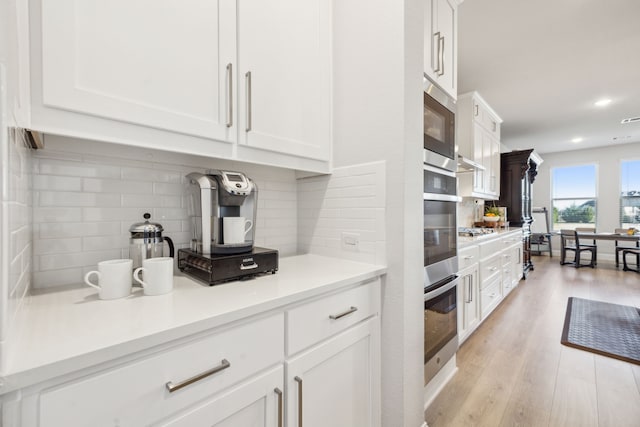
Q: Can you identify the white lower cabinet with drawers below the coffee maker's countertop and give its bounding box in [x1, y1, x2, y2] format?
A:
[12, 279, 381, 427]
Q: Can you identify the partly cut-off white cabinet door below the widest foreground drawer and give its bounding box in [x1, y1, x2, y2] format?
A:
[164, 366, 284, 427]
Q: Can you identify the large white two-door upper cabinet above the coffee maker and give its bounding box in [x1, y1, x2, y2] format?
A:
[28, 0, 331, 172]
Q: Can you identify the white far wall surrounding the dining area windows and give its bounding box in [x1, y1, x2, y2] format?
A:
[532, 143, 640, 261]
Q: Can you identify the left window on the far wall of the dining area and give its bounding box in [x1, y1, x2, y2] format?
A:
[551, 165, 597, 230]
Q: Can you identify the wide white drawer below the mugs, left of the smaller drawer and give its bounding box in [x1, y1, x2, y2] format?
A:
[39, 313, 284, 427]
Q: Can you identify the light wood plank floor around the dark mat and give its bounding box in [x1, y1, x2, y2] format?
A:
[425, 256, 640, 427]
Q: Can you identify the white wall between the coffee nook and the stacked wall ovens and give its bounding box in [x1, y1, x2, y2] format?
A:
[333, 0, 424, 427]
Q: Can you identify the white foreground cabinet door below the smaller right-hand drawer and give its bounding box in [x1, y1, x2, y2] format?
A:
[286, 316, 380, 427]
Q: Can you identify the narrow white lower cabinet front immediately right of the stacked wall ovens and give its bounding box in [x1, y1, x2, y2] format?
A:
[458, 263, 480, 344]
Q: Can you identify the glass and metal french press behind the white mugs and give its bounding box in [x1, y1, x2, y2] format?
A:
[129, 213, 174, 270]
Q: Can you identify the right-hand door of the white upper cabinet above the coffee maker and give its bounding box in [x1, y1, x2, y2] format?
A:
[237, 0, 331, 160]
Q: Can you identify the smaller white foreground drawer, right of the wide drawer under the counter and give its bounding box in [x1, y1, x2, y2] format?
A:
[287, 280, 380, 355]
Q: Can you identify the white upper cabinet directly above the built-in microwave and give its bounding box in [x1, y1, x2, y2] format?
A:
[424, 0, 460, 99]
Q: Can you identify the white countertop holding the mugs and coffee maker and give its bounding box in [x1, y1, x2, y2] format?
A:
[0, 255, 386, 394]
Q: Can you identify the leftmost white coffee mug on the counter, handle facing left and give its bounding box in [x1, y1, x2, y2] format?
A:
[84, 259, 133, 299]
